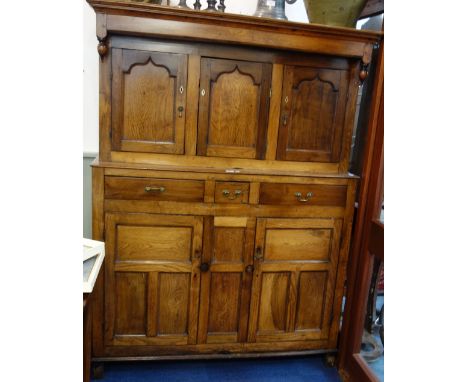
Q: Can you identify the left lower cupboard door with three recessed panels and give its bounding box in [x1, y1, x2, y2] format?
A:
[105, 213, 203, 346]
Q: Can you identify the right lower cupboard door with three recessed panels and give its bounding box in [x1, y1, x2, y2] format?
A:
[248, 219, 342, 342]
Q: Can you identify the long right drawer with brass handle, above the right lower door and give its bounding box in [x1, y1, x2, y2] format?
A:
[259, 183, 347, 207]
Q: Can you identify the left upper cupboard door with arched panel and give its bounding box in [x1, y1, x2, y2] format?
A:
[112, 49, 187, 154]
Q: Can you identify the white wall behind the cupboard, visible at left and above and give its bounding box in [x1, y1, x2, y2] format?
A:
[83, 0, 308, 153]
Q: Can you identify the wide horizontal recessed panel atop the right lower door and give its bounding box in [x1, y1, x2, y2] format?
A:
[265, 228, 332, 261]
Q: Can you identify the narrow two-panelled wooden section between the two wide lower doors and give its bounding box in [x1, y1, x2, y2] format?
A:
[198, 217, 255, 344]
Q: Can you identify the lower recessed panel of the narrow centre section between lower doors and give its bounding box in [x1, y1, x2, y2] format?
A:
[208, 273, 242, 333]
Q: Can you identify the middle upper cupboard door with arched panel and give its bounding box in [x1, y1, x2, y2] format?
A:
[198, 58, 271, 159]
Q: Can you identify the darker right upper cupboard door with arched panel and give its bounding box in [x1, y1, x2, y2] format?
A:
[277, 66, 348, 162]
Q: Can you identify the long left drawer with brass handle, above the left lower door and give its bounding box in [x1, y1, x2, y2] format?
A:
[104, 176, 205, 202]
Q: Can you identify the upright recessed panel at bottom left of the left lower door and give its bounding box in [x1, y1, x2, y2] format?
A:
[115, 272, 146, 335]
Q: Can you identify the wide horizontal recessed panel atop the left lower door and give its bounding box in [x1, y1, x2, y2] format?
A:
[117, 225, 192, 261]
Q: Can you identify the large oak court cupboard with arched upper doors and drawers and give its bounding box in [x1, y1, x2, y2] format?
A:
[88, 0, 380, 360]
